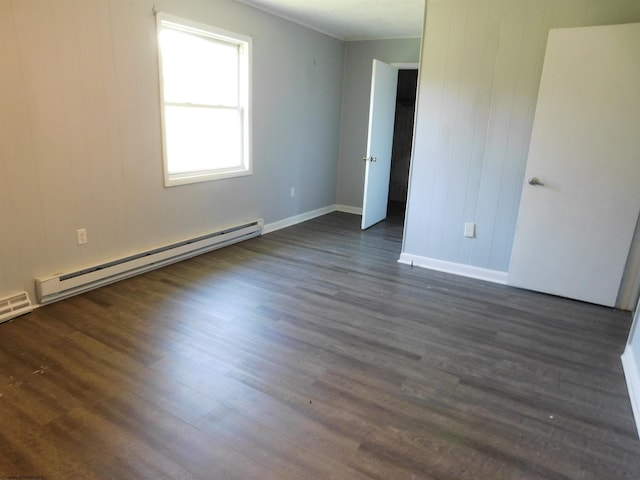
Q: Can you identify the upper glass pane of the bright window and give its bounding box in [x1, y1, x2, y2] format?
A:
[160, 28, 238, 107]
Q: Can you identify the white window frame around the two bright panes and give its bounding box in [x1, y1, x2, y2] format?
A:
[156, 12, 253, 187]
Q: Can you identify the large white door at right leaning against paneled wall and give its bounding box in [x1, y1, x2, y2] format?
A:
[508, 24, 640, 306]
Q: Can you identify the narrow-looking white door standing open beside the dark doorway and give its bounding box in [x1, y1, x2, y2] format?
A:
[362, 60, 398, 229]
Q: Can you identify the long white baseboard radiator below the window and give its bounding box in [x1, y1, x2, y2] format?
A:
[36, 219, 264, 304]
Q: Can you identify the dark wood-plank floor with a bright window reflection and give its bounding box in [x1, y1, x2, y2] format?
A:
[0, 213, 640, 480]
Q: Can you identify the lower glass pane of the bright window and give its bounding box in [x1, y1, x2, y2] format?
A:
[165, 106, 242, 174]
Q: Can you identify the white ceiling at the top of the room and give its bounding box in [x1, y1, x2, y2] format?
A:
[232, 0, 425, 41]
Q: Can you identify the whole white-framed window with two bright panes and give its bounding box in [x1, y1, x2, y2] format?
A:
[157, 13, 251, 187]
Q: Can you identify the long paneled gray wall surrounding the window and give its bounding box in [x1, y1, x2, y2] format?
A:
[0, 0, 344, 298]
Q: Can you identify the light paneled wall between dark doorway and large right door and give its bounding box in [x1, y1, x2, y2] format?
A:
[403, 0, 640, 272]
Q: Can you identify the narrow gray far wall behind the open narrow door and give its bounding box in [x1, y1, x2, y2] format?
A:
[337, 38, 420, 208]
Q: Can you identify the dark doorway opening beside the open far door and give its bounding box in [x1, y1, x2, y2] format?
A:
[387, 68, 418, 223]
